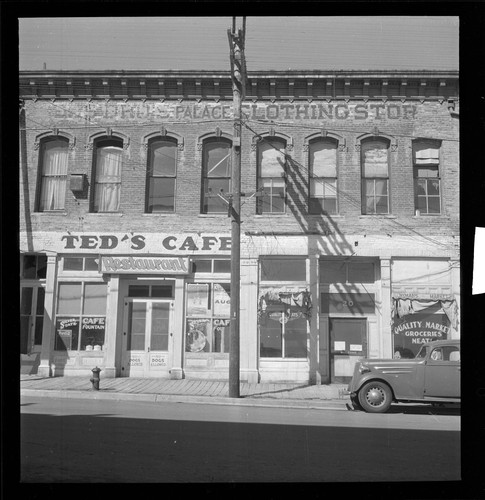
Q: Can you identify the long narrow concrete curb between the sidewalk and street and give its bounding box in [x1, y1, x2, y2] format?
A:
[20, 389, 348, 411]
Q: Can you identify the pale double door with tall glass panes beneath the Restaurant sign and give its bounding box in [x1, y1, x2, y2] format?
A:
[121, 298, 173, 377]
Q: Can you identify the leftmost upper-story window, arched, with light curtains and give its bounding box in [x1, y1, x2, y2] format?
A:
[37, 137, 69, 212]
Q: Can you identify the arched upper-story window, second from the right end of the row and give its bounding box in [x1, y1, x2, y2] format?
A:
[361, 139, 389, 215]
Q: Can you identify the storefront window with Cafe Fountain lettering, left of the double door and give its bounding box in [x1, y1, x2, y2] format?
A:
[54, 282, 108, 351]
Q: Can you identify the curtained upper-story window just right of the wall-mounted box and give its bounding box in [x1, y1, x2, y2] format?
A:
[92, 139, 123, 212]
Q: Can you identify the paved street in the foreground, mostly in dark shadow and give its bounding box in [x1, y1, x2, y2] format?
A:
[21, 396, 460, 483]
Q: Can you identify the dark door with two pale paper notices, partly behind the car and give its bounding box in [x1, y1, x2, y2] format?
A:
[330, 318, 367, 383]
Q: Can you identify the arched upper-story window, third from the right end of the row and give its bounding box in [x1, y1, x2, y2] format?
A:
[308, 139, 337, 214]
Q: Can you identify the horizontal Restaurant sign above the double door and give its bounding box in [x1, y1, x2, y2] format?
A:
[99, 255, 189, 274]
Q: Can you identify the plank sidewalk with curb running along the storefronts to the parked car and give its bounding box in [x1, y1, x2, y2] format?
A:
[20, 375, 349, 410]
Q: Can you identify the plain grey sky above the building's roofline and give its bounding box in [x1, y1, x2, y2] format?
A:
[19, 16, 459, 71]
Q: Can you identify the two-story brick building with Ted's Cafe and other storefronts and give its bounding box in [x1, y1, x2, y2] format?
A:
[20, 71, 460, 383]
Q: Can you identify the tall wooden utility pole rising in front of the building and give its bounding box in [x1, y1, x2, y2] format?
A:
[227, 17, 246, 398]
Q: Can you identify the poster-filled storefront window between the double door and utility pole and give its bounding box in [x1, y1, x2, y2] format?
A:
[185, 283, 231, 353]
